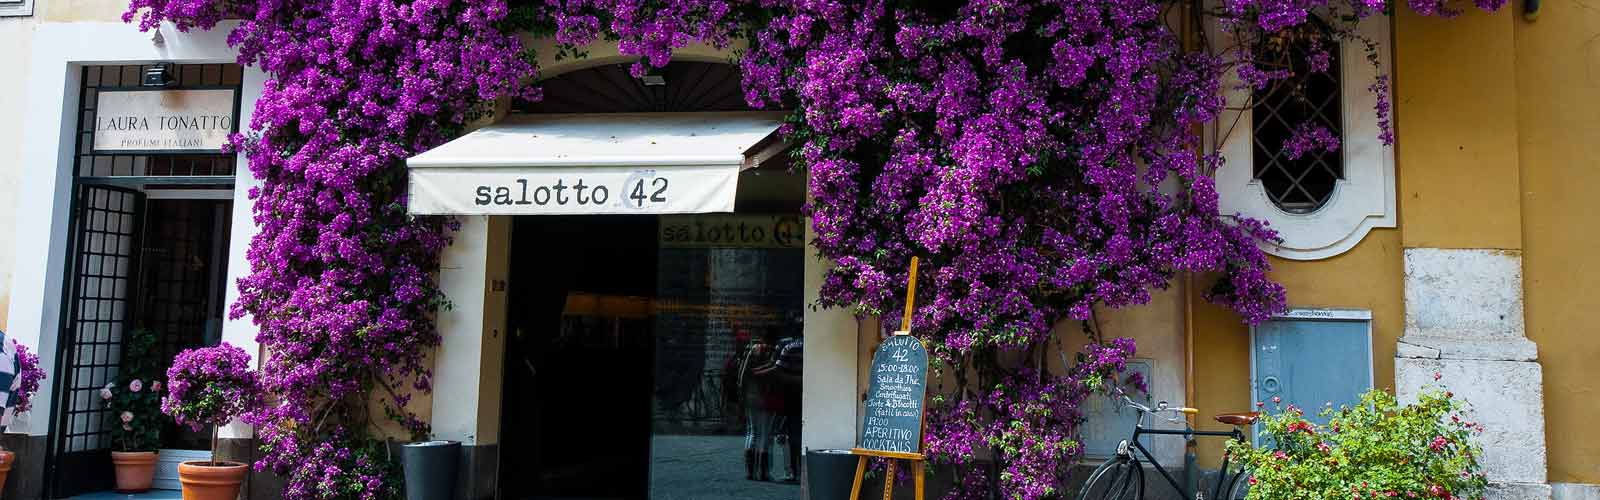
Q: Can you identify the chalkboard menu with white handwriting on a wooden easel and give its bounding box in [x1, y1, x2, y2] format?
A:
[856, 335, 928, 454]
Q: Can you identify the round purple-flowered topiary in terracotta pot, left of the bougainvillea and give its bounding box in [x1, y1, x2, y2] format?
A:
[162, 343, 261, 500]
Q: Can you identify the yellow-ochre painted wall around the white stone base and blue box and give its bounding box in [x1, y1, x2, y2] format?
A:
[1192, 2, 1600, 484]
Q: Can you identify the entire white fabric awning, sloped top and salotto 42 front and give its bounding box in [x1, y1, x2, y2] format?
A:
[406, 112, 782, 215]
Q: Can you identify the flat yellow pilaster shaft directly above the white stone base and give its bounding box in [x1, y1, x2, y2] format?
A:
[1394, 8, 1522, 250]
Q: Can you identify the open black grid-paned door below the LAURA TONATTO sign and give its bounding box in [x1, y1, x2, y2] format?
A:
[50, 184, 144, 498]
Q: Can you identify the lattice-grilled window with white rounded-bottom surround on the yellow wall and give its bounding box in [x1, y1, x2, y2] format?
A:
[1206, 16, 1395, 260]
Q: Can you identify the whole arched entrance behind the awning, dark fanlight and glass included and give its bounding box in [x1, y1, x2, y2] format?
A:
[499, 63, 805, 498]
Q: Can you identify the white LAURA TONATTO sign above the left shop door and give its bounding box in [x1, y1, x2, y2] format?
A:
[94, 88, 238, 152]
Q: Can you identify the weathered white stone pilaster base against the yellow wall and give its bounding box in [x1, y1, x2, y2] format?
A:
[1395, 248, 1550, 500]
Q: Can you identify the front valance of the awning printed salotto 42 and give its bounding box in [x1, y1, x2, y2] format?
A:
[408, 165, 739, 215]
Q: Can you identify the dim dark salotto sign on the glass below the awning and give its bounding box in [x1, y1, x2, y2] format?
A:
[659, 213, 805, 248]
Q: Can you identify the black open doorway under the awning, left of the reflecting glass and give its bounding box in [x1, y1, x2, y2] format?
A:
[501, 216, 658, 498]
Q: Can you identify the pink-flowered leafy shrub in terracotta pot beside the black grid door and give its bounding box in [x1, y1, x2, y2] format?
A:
[101, 329, 162, 494]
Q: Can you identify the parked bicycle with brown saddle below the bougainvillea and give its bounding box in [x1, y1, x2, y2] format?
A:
[1078, 389, 1261, 500]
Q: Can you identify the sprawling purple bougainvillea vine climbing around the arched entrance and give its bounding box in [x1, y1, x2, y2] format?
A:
[126, 0, 1504, 500]
